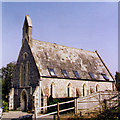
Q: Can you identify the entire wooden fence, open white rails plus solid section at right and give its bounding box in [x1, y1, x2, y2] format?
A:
[35, 91, 118, 119]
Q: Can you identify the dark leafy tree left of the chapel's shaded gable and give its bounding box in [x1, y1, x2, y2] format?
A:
[0, 62, 16, 102]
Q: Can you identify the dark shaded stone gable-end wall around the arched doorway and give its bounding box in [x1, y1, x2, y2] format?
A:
[12, 40, 40, 109]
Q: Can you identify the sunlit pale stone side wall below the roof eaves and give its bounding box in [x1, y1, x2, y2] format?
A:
[41, 78, 113, 98]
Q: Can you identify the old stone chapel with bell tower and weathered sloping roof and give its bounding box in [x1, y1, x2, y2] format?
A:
[9, 15, 115, 111]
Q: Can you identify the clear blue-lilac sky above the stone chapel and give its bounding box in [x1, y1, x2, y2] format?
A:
[0, 2, 118, 75]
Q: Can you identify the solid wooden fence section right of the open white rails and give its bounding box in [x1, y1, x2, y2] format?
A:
[77, 91, 118, 114]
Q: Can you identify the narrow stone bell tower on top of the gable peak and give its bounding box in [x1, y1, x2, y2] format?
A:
[22, 15, 32, 45]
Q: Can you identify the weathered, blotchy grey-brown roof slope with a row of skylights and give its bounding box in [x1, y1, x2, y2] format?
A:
[31, 40, 113, 81]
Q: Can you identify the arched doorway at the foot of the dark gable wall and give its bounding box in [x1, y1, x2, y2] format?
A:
[20, 90, 28, 112]
